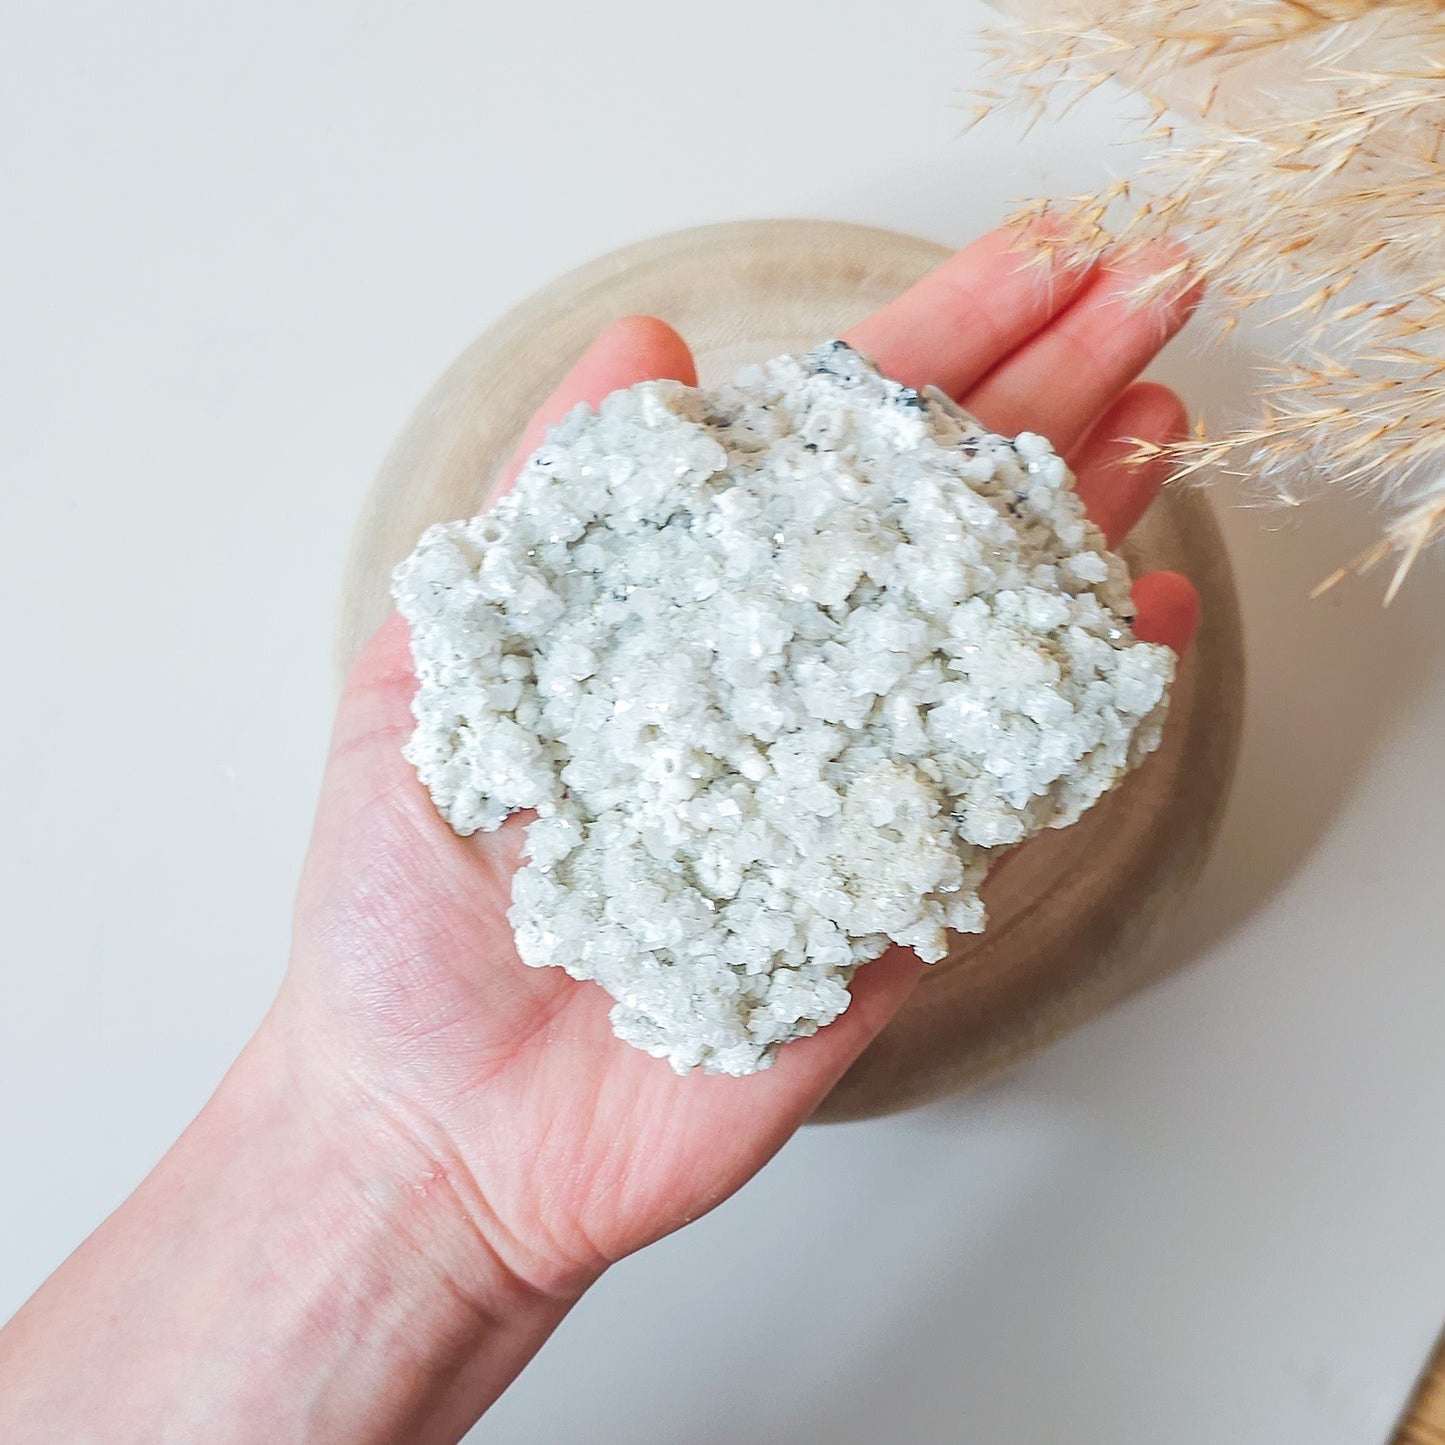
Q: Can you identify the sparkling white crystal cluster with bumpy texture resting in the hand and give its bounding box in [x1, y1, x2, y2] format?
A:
[393, 342, 1173, 1074]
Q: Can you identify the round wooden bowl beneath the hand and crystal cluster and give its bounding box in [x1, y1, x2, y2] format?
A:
[337, 221, 1243, 1118]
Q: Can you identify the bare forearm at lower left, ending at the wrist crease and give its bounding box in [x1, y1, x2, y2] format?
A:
[0, 1011, 586, 1445]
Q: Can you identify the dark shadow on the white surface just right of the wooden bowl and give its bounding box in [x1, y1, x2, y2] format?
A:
[1159, 347, 1442, 964]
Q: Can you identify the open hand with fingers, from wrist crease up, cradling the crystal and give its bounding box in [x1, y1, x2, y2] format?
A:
[283, 233, 1196, 1290]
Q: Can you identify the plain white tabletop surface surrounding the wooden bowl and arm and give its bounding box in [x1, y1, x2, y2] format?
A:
[0, 0, 1445, 1445]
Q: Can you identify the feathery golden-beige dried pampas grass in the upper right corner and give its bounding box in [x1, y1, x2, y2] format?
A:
[978, 0, 1445, 600]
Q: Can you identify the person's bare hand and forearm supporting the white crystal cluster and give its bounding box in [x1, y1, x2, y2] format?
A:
[0, 225, 1198, 1445]
